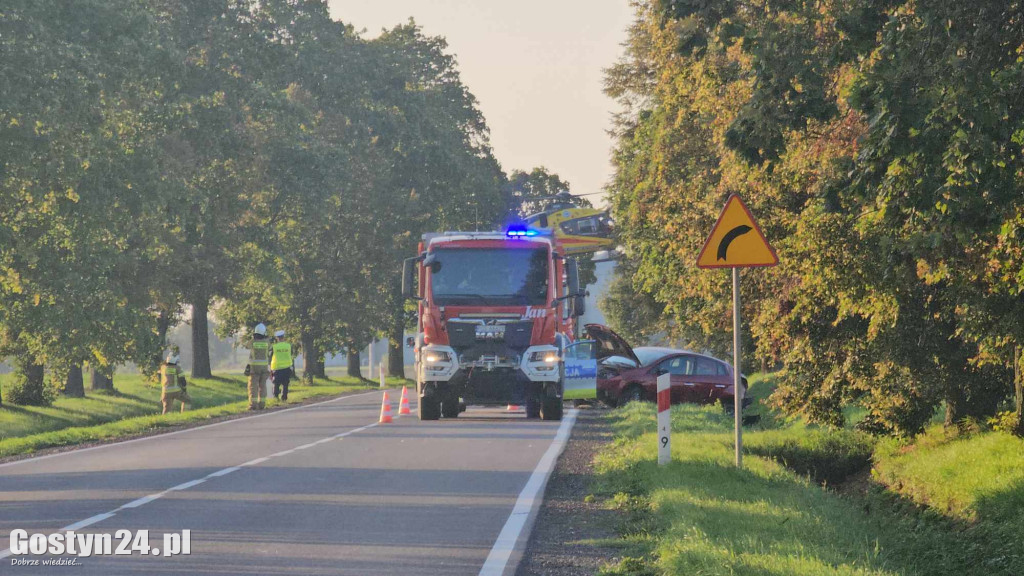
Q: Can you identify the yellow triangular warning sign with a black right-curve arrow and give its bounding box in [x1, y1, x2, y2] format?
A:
[697, 194, 778, 268]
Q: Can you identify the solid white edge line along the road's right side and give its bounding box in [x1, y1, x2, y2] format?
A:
[479, 409, 578, 576]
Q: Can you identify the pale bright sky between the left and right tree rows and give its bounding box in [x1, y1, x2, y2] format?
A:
[329, 0, 633, 205]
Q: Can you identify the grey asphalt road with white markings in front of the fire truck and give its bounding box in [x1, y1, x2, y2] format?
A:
[0, 392, 574, 576]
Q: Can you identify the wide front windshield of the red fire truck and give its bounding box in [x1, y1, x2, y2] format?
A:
[428, 243, 549, 305]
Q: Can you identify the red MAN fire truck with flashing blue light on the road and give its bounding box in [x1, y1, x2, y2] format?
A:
[402, 229, 585, 420]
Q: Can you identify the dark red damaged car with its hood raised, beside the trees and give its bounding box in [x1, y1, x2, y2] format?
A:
[586, 324, 751, 412]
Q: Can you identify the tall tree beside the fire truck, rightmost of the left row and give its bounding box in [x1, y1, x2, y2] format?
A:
[370, 20, 505, 377]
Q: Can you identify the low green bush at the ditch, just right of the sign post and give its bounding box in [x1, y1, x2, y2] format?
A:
[743, 428, 874, 485]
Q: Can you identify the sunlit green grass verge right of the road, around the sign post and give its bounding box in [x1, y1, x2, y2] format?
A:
[595, 399, 1024, 576]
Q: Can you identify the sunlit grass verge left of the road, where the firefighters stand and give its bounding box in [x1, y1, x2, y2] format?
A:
[0, 374, 407, 457]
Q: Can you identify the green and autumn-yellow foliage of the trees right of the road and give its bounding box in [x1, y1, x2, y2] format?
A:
[606, 0, 1024, 436]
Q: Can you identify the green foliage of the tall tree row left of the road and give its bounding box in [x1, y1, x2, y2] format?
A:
[0, 0, 505, 389]
